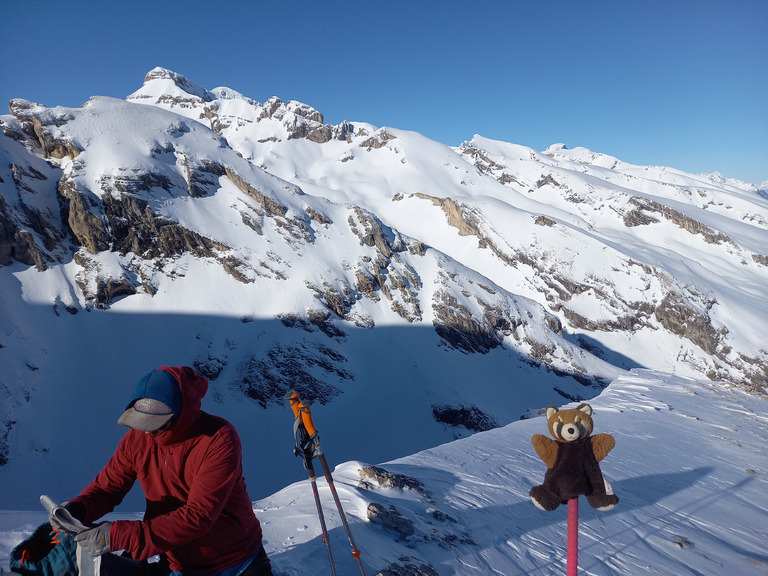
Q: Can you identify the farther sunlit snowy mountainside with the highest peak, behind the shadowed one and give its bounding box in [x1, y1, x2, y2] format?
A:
[129, 70, 768, 390]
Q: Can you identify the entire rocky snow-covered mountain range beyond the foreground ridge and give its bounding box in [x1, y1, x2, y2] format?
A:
[0, 68, 768, 573]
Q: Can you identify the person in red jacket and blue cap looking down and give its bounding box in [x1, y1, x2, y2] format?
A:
[51, 366, 272, 576]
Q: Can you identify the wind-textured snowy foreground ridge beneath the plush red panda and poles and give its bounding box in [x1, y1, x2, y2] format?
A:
[0, 370, 768, 576]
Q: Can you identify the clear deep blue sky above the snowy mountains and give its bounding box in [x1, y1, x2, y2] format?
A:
[0, 0, 768, 184]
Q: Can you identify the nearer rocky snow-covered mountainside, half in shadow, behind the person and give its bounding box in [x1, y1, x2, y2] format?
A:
[0, 90, 621, 507]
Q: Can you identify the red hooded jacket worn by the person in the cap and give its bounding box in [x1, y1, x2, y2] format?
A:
[73, 366, 261, 575]
